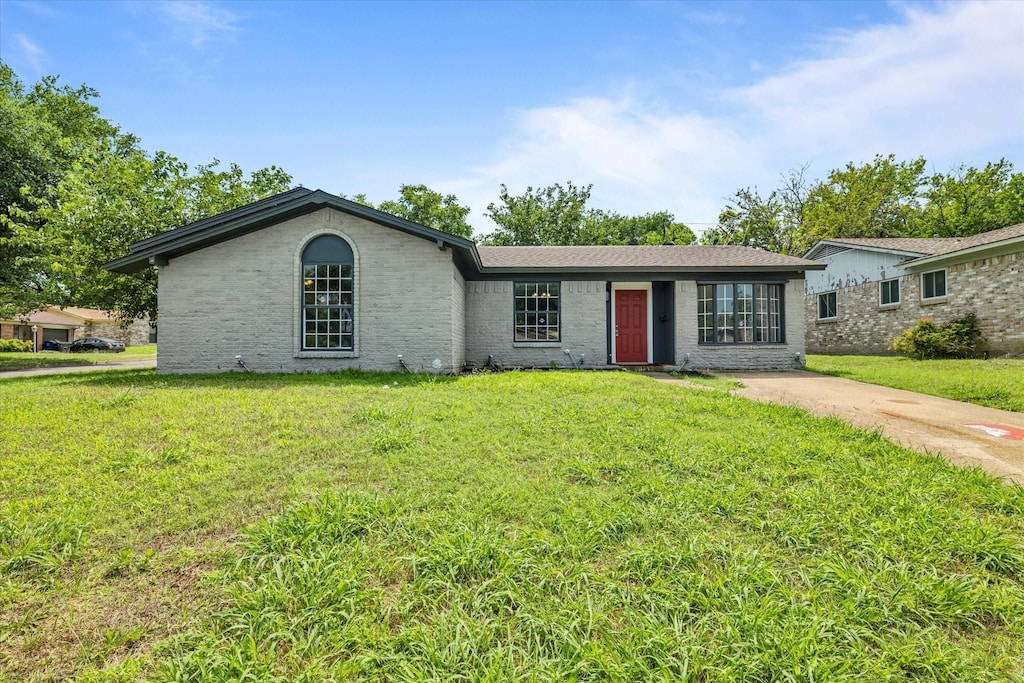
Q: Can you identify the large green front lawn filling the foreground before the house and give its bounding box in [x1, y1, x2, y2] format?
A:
[0, 371, 1024, 682]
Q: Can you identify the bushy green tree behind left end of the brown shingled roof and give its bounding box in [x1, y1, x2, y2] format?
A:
[481, 181, 593, 247]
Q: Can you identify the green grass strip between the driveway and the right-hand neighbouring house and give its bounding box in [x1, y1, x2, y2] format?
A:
[807, 355, 1024, 413]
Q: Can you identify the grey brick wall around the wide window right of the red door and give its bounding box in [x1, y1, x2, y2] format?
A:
[676, 278, 805, 370]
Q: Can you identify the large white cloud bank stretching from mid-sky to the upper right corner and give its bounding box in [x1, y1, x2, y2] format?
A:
[450, 2, 1024, 231]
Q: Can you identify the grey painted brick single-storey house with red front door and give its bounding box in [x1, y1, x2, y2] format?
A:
[106, 187, 822, 373]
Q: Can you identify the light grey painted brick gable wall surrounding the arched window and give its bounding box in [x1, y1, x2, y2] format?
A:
[158, 209, 462, 373]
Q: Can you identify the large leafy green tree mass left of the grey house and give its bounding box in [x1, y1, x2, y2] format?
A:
[0, 62, 291, 321]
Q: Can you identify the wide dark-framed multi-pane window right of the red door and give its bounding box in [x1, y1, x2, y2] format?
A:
[697, 284, 782, 344]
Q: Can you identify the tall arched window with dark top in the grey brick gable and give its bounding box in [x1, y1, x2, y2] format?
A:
[302, 234, 355, 351]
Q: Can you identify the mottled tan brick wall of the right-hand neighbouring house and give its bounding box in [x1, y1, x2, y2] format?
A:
[804, 253, 1024, 354]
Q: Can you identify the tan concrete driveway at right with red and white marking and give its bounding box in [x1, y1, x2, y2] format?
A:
[716, 371, 1024, 484]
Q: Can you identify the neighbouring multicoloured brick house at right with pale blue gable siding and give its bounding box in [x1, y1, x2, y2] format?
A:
[805, 223, 1024, 354]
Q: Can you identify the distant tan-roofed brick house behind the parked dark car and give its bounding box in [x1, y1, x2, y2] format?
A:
[0, 306, 156, 348]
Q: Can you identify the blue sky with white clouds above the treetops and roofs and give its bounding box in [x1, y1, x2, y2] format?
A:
[0, 0, 1024, 231]
